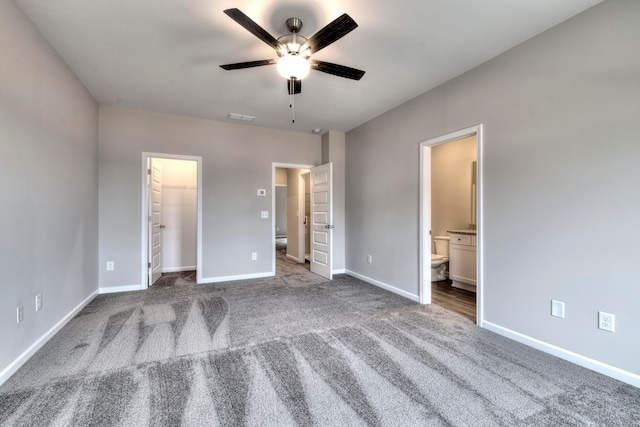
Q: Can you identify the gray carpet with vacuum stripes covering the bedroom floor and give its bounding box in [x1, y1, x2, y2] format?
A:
[0, 251, 640, 426]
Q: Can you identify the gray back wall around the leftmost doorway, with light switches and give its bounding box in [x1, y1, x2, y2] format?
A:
[99, 106, 320, 288]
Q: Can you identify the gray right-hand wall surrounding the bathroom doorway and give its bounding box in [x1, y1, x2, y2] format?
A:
[346, 0, 640, 375]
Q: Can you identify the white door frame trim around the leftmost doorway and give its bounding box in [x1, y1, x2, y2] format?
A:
[140, 151, 203, 289]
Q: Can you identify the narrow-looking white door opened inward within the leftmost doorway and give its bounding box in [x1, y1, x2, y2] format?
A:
[149, 159, 164, 286]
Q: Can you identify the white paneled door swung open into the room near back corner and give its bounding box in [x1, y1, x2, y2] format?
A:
[310, 163, 333, 280]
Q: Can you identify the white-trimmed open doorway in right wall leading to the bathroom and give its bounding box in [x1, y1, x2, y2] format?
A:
[420, 125, 483, 325]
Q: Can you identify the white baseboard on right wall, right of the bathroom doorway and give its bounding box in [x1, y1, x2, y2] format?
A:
[480, 321, 640, 387]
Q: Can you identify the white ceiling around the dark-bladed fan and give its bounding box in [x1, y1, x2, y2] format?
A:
[17, 0, 602, 132]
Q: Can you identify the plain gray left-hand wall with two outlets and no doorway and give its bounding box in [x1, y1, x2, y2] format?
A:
[0, 1, 98, 382]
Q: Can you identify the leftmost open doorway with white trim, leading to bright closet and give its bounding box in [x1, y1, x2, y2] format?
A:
[141, 153, 202, 288]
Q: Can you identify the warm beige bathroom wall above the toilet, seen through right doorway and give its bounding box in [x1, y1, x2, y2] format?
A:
[431, 136, 476, 239]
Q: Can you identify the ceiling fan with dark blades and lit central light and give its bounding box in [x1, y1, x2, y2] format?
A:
[220, 8, 364, 98]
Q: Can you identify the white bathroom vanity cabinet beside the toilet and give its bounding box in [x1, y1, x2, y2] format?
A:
[448, 230, 476, 292]
